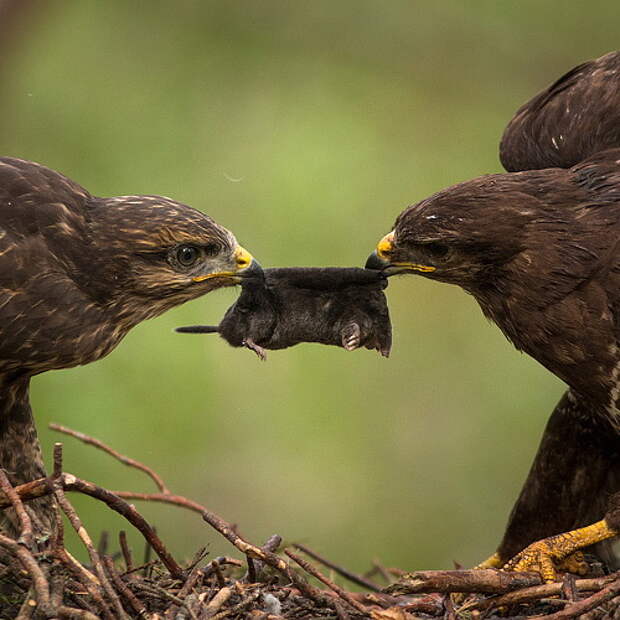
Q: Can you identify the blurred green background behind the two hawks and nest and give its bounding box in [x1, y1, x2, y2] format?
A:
[0, 0, 620, 571]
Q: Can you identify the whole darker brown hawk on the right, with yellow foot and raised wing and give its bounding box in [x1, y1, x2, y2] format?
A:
[367, 53, 620, 581]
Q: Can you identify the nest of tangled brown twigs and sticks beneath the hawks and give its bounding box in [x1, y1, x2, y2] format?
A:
[0, 425, 620, 620]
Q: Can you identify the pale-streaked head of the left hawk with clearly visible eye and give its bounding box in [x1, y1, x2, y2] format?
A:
[84, 196, 261, 316]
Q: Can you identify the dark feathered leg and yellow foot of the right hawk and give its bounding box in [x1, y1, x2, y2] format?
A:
[494, 391, 620, 581]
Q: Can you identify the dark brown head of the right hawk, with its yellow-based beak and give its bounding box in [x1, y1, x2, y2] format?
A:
[366, 174, 545, 292]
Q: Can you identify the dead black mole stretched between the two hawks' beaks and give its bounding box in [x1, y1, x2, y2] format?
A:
[177, 267, 392, 360]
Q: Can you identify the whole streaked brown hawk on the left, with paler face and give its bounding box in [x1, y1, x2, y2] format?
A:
[0, 157, 260, 536]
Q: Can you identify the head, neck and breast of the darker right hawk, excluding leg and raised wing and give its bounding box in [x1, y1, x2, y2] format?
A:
[366, 157, 620, 392]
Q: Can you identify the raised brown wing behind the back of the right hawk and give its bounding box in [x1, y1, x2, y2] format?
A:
[499, 52, 620, 172]
